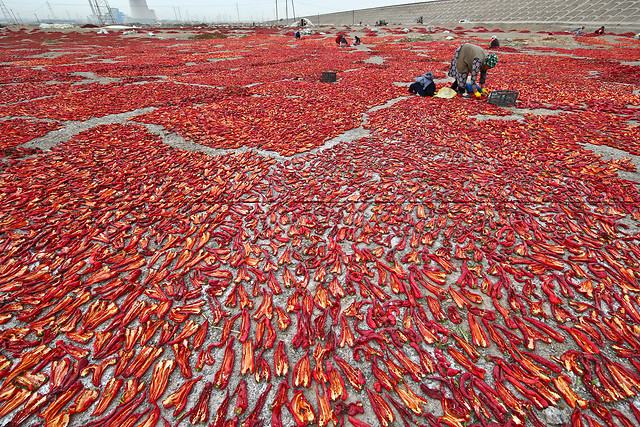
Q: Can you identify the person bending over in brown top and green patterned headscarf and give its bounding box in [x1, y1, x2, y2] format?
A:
[449, 43, 498, 94]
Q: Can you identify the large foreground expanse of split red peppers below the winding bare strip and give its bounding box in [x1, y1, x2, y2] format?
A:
[0, 27, 640, 425]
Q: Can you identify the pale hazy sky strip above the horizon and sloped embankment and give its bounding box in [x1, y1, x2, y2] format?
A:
[0, 0, 430, 22]
